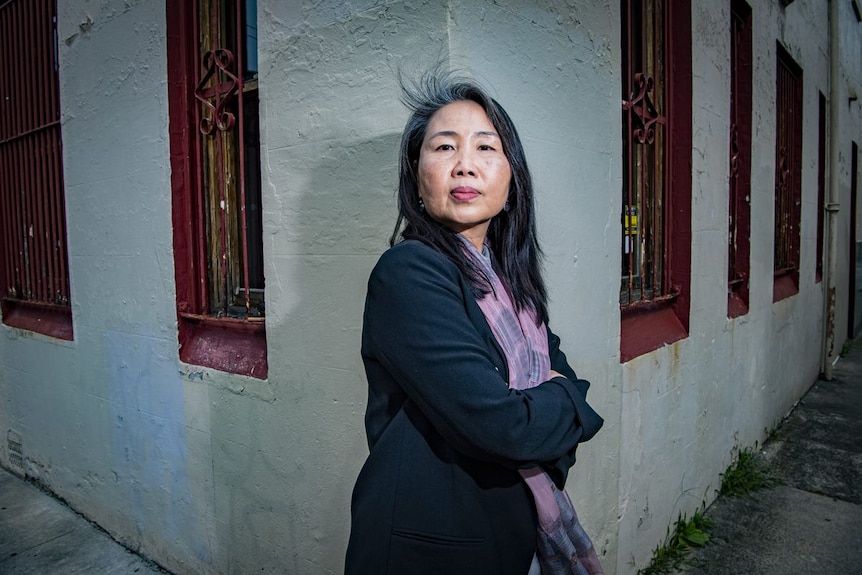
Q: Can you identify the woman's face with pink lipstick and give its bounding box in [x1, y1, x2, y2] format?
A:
[418, 100, 512, 249]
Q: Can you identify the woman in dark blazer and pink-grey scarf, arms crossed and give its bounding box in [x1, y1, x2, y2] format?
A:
[346, 73, 602, 575]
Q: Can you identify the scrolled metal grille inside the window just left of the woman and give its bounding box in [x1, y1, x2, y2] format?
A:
[193, 0, 265, 321]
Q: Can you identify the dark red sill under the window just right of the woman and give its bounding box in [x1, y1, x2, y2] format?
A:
[620, 302, 688, 363]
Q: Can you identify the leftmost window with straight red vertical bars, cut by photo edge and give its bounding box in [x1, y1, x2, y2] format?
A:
[0, 0, 72, 340]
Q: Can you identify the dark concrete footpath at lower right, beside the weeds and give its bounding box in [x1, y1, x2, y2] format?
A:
[679, 339, 862, 575]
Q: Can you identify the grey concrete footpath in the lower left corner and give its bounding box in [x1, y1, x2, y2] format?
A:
[0, 469, 167, 575]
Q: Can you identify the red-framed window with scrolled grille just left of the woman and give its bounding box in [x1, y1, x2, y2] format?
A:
[166, 0, 267, 378]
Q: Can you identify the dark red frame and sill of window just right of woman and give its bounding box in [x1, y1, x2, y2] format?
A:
[620, 0, 692, 363]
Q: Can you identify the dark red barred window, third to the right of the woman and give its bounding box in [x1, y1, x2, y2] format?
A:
[772, 44, 802, 301]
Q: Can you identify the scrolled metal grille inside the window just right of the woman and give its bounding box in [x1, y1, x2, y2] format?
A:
[620, 0, 674, 307]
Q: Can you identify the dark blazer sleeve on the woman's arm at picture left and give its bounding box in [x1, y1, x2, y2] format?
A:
[363, 242, 584, 467]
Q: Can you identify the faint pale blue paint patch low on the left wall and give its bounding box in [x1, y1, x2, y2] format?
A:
[105, 331, 209, 561]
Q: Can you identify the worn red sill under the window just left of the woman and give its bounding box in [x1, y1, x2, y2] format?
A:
[179, 314, 269, 379]
